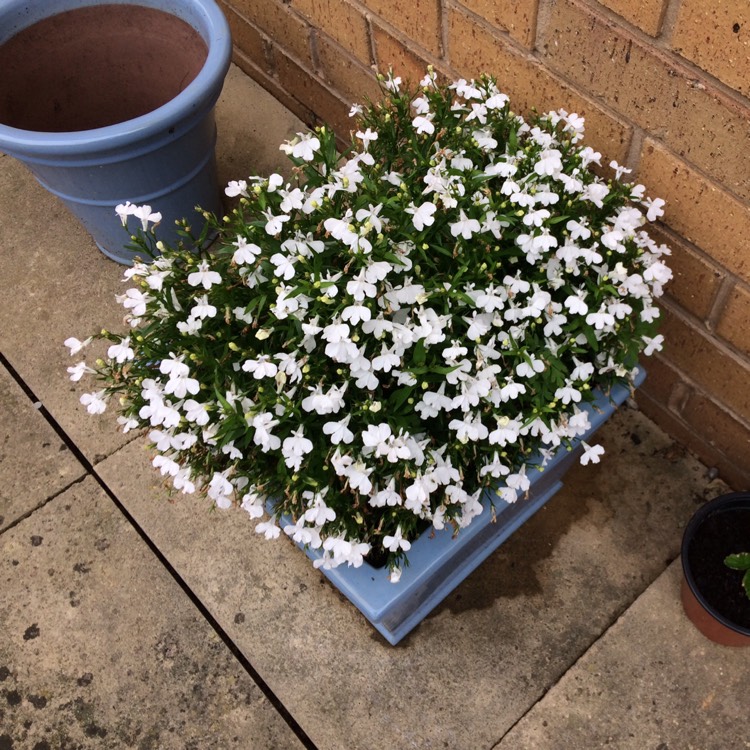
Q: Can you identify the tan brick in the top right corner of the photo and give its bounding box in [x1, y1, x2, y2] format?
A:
[672, 0, 750, 96]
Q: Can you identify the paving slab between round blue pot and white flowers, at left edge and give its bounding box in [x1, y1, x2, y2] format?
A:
[0, 150, 140, 461]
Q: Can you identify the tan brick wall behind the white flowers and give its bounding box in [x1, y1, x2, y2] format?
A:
[221, 0, 750, 489]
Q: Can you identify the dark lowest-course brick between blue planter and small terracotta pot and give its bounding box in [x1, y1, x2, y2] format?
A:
[636, 388, 750, 490]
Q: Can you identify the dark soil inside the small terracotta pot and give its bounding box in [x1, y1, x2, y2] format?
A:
[688, 508, 750, 629]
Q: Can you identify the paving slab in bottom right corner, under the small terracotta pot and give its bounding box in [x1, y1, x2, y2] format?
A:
[495, 560, 750, 750]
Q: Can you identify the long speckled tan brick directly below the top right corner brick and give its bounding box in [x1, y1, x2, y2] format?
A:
[537, 0, 750, 203]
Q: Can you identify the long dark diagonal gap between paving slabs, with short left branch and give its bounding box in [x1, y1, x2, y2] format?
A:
[0, 353, 316, 750]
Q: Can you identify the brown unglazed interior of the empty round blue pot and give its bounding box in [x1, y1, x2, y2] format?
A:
[0, 4, 208, 133]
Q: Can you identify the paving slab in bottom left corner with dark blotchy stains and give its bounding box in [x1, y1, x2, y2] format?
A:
[0, 478, 301, 750]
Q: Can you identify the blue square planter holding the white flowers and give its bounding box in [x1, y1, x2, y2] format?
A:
[284, 368, 645, 645]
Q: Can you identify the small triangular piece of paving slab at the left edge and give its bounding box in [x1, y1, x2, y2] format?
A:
[0, 365, 85, 532]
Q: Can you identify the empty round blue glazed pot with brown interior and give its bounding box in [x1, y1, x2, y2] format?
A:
[0, 0, 232, 264]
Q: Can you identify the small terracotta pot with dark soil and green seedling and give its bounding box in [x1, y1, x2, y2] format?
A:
[681, 492, 750, 646]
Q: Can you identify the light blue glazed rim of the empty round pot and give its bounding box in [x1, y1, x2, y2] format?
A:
[0, 0, 232, 156]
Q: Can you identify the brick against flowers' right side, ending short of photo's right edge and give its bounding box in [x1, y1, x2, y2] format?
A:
[649, 226, 726, 320]
